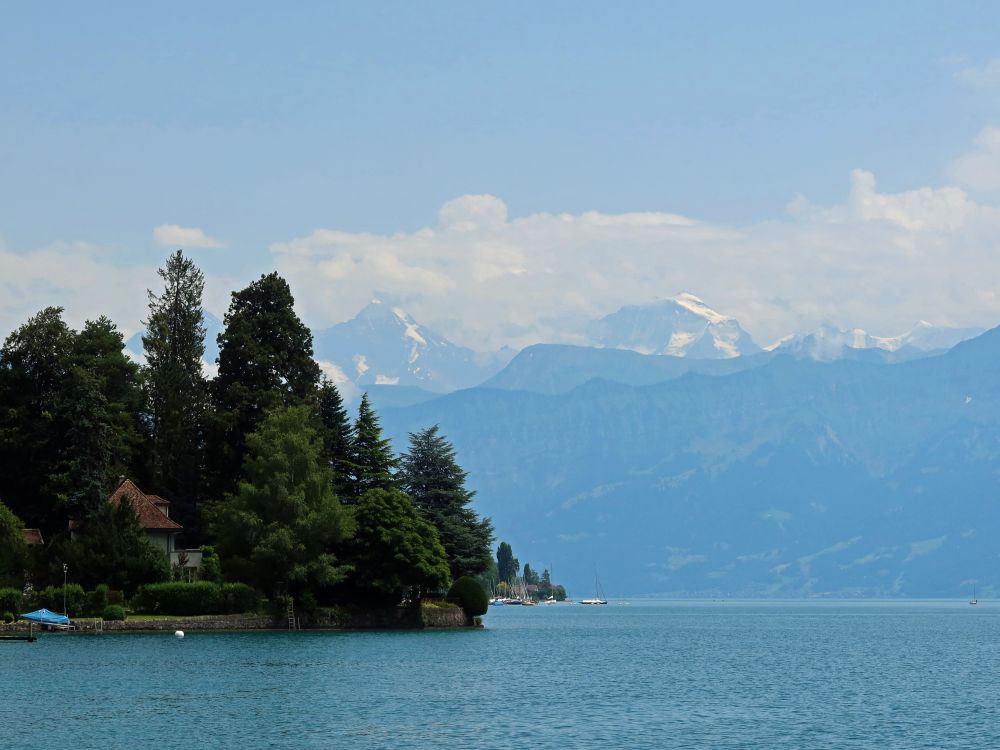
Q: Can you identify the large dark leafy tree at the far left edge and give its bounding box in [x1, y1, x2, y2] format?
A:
[0, 307, 76, 533]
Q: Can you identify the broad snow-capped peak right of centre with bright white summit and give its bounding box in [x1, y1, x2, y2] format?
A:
[588, 292, 760, 359]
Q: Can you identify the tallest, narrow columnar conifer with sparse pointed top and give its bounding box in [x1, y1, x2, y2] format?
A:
[142, 250, 208, 544]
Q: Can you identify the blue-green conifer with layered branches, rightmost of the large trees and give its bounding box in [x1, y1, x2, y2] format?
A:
[399, 425, 493, 580]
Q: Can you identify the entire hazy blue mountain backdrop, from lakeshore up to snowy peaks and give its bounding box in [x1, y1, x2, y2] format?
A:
[130, 295, 1000, 597]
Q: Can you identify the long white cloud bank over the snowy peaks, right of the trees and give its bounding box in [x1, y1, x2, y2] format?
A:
[271, 151, 1000, 350]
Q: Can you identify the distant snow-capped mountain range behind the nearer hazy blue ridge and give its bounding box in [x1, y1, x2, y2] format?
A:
[127, 293, 982, 405]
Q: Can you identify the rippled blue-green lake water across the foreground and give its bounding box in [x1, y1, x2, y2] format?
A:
[0, 601, 1000, 750]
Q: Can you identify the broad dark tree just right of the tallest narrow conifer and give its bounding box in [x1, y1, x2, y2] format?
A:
[209, 273, 319, 498]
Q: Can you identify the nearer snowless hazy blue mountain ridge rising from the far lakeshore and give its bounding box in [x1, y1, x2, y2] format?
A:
[382, 329, 1000, 597]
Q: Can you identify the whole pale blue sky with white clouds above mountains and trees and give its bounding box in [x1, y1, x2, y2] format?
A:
[0, 2, 1000, 348]
